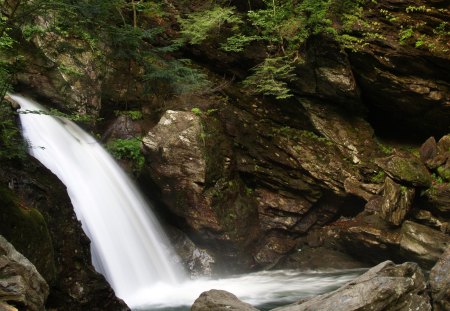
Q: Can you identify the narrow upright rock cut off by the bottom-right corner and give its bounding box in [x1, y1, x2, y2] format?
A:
[429, 247, 450, 311]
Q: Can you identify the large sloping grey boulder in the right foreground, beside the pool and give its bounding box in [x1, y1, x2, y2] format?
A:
[273, 261, 431, 311]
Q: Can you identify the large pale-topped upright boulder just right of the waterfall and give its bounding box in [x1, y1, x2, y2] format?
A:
[143, 110, 222, 232]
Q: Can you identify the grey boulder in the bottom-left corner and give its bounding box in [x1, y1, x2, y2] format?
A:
[0, 235, 49, 311]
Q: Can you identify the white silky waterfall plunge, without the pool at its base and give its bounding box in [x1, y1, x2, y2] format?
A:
[11, 95, 184, 302]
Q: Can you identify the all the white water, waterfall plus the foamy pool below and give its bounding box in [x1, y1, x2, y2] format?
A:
[11, 95, 362, 310]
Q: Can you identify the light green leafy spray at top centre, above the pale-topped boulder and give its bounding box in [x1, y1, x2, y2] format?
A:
[179, 6, 242, 44]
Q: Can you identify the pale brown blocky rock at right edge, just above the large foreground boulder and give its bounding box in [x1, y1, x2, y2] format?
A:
[400, 221, 450, 268]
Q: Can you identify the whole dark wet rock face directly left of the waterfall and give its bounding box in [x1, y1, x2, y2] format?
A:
[0, 158, 128, 311]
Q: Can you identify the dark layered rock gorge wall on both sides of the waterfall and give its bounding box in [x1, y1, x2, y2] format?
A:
[0, 0, 450, 310]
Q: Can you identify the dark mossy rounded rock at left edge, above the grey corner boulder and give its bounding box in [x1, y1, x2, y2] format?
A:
[0, 186, 56, 284]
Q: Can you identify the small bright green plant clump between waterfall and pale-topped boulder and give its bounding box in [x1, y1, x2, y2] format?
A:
[106, 138, 145, 174]
